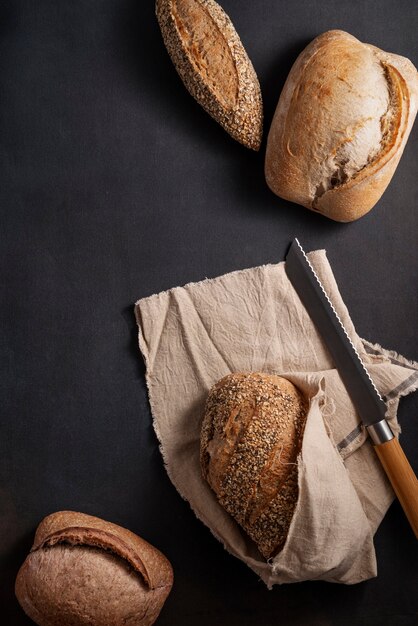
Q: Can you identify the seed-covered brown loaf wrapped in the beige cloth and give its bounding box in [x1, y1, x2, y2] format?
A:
[200, 373, 307, 558]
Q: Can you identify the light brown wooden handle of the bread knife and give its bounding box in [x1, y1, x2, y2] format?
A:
[374, 437, 418, 539]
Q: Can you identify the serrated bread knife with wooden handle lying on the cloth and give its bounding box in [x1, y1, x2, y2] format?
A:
[285, 239, 418, 538]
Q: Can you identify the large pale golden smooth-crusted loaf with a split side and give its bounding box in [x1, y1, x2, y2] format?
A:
[265, 30, 418, 222]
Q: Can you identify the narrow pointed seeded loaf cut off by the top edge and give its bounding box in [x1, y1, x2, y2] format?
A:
[156, 0, 263, 150]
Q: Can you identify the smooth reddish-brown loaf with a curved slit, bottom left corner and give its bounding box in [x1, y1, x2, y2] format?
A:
[15, 511, 173, 626]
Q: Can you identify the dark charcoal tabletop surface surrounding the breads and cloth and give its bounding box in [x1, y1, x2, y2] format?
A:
[0, 0, 418, 626]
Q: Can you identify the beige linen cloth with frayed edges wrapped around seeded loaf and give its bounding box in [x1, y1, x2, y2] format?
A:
[135, 250, 418, 587]
